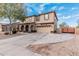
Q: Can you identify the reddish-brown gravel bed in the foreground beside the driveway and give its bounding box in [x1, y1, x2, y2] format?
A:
[28, 35, 79, 56]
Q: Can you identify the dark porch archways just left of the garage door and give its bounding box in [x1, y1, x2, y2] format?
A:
[18, 23, 36, 32]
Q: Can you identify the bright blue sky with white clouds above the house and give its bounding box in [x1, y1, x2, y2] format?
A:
[25, 3, 79, 27]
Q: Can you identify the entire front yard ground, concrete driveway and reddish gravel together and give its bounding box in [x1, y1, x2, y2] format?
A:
[0, 33, 76, 56]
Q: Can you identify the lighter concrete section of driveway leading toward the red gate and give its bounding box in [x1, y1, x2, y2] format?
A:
[32, 34, 75, 44]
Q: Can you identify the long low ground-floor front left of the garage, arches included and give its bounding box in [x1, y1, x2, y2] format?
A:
[2, 23, 36, 33]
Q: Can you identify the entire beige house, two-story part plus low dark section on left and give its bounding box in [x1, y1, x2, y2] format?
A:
[2, 12, 58, 33]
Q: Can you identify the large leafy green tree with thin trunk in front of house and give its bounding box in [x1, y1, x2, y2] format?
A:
[0, 3, 25, 34]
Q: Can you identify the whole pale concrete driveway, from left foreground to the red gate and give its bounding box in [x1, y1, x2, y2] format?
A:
[0, 33, 75, 56]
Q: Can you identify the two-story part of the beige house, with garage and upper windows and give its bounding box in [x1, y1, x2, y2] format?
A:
[24, 12, 58, 33]
